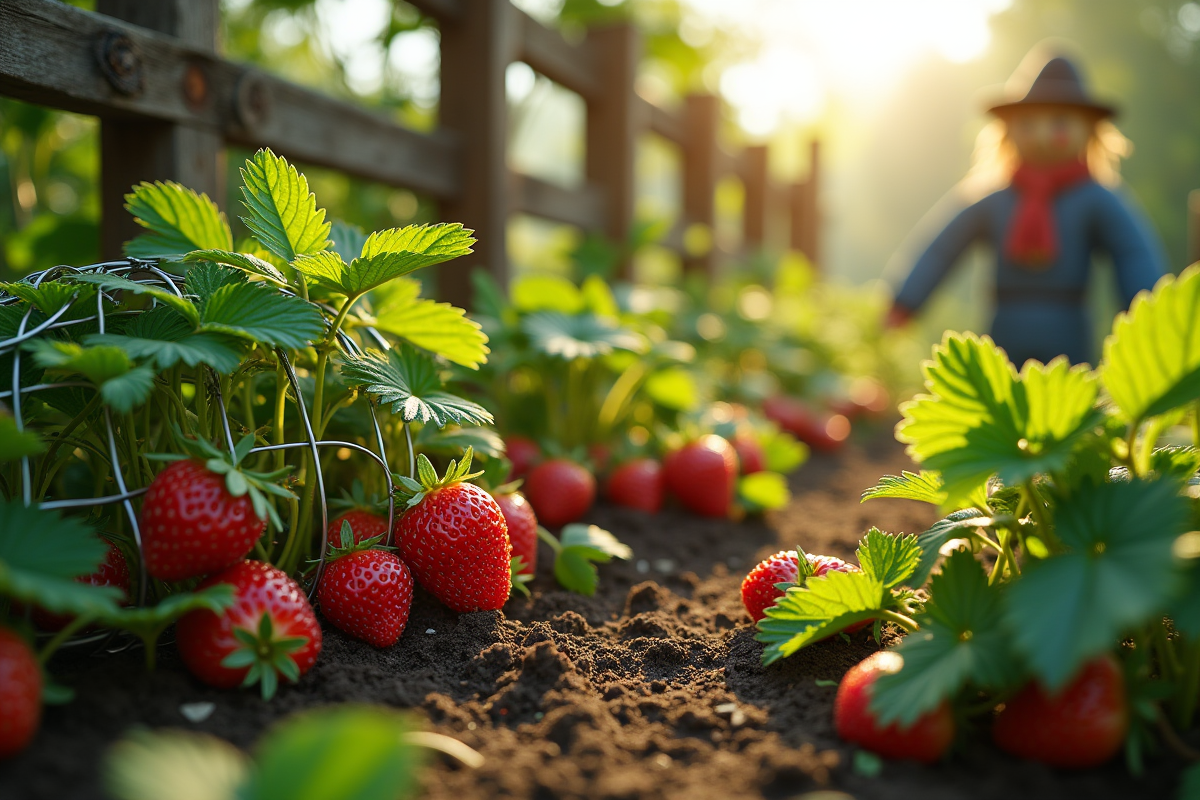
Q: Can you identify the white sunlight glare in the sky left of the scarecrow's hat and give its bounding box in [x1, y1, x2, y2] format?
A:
[685, 0, 1010, 136]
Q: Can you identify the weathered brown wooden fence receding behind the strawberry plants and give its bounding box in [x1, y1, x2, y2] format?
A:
[0, 0, 820, 305]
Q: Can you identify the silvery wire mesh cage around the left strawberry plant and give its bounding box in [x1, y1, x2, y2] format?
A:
[0, 259, 403, 643]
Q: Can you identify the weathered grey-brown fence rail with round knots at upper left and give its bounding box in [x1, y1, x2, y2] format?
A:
[0, 0, 458, 198]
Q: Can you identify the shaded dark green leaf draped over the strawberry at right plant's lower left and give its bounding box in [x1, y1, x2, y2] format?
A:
[871, 551, 1018, 727]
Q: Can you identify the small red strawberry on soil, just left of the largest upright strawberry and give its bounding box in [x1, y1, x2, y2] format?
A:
[317, 524, 413, 648]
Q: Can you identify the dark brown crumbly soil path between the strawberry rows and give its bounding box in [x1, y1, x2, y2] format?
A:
[0, 432, 1178, 800]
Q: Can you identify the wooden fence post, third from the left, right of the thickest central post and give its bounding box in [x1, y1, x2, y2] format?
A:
[587, 24, 642, 279]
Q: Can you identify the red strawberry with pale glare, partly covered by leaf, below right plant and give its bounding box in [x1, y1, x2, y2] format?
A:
[833, 650, 954, 764]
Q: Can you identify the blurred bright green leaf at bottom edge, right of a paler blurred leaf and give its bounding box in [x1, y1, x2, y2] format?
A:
[245, 705, 420, 800]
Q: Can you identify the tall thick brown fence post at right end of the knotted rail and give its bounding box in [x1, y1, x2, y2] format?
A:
[438, 0, 517, 308]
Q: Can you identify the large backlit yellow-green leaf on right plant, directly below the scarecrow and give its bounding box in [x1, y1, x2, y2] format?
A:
[896, 333, 1100, 504]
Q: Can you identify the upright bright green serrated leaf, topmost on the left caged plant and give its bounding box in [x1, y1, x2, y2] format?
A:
[238, 148, 329, 263]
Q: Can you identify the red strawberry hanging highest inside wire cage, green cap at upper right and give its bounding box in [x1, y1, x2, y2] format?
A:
[142, 435, 292, 581]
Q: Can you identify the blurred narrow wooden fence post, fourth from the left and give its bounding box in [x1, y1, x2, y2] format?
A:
[683, 95, 720, 277]
